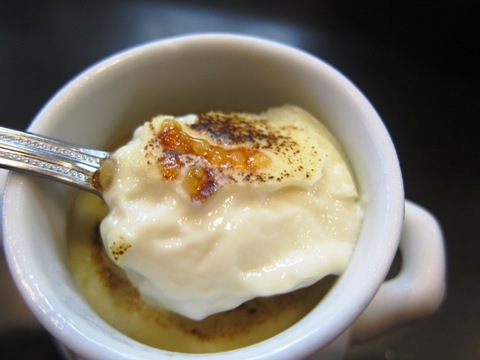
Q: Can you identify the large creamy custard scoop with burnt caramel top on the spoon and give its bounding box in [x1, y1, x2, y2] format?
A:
[100, 105, 363, 320]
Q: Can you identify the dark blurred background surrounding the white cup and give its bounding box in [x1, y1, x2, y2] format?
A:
[0, 0, 480, 360]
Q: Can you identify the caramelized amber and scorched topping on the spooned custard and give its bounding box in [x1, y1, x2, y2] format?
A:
[144, 112, 321, 203]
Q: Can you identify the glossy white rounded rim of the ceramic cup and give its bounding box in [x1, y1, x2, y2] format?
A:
[3, 33, 404, 359]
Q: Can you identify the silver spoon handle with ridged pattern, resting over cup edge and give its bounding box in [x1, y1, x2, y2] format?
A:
[0, 127, 110, 195]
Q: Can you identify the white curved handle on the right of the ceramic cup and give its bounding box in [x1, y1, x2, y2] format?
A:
[350, 201, 446, 343]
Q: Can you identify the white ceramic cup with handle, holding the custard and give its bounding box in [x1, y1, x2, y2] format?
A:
[3, 34, 445, 360]
